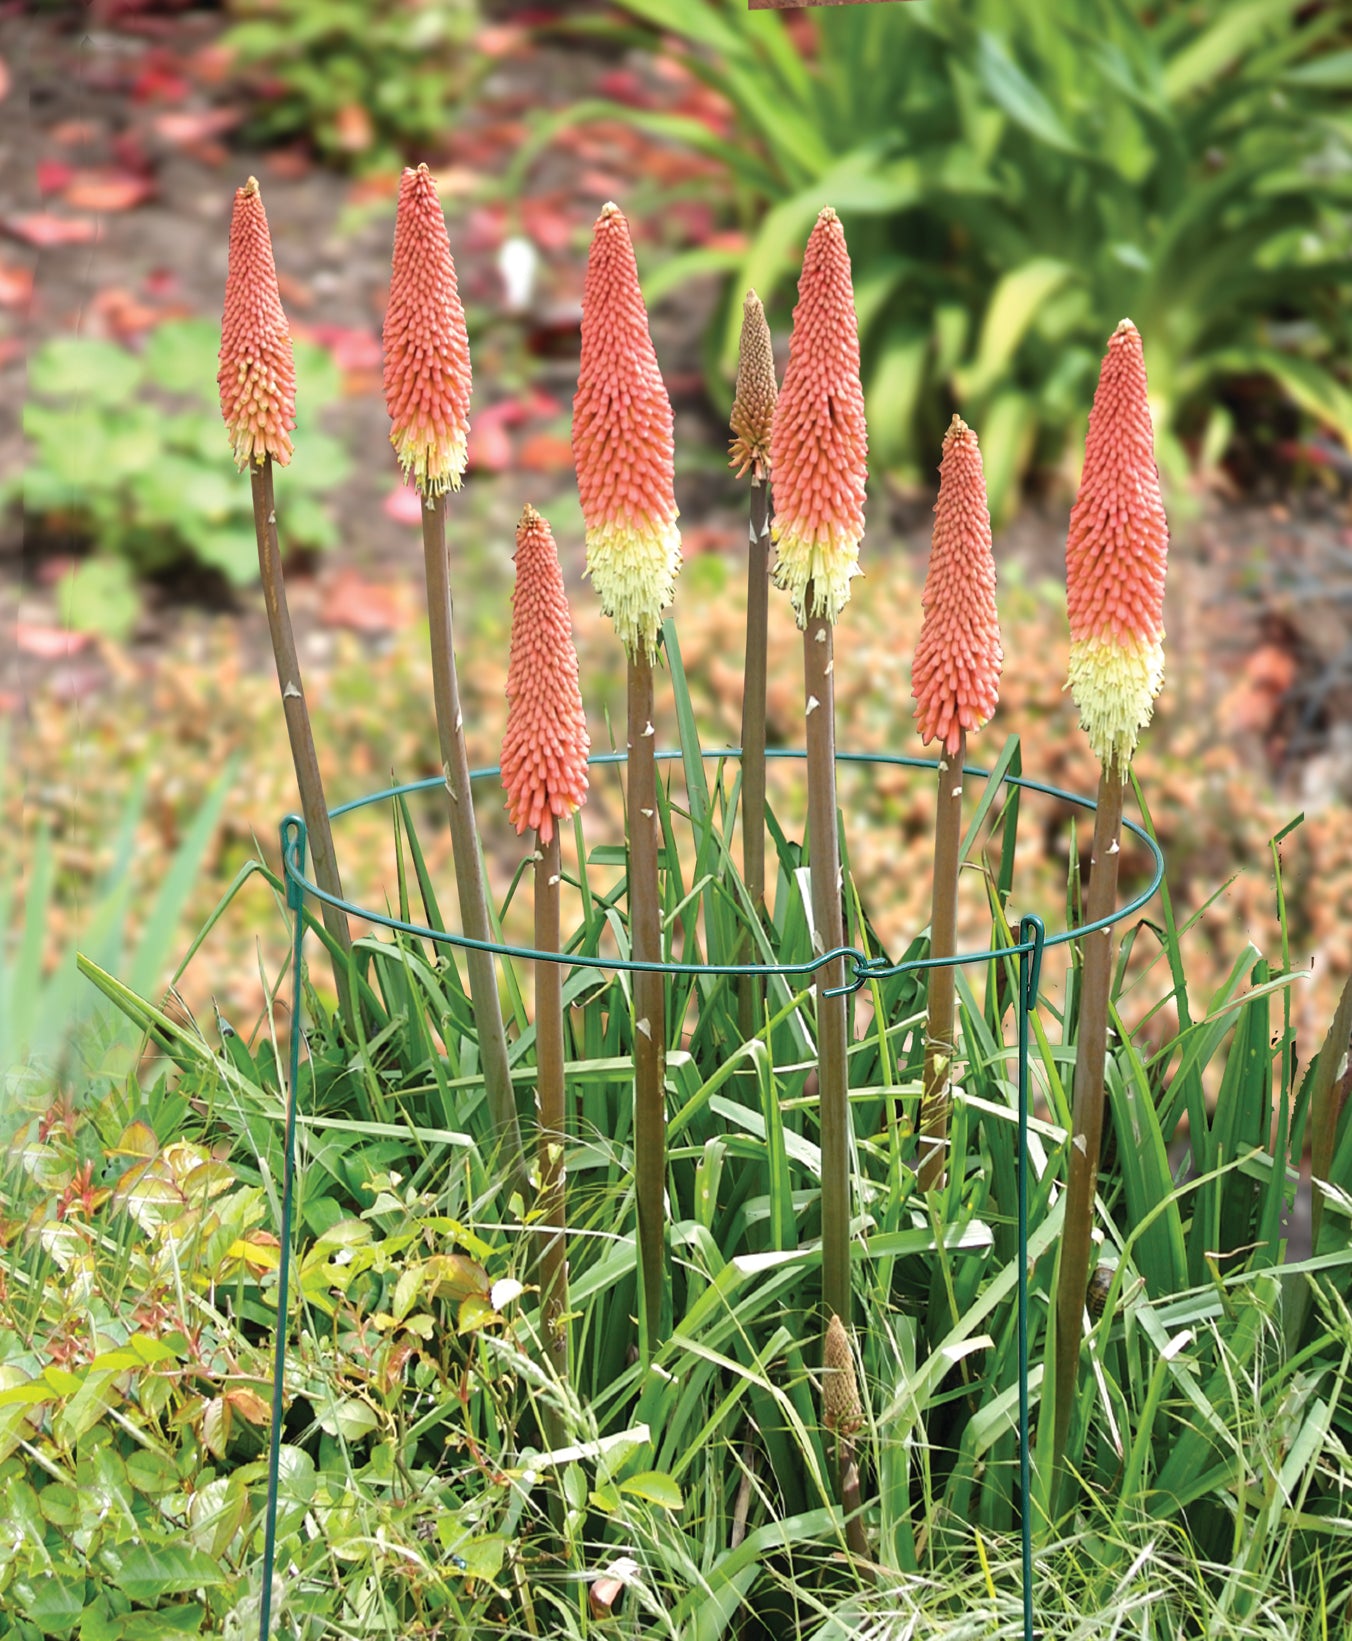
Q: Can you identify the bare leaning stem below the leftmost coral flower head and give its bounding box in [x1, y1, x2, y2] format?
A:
[249, 456, 353, 1022]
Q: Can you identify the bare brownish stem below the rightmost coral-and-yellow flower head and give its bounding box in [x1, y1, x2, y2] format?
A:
[1052, 758, 1122, 1469]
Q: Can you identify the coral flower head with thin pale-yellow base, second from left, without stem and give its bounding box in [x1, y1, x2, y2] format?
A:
[382, 166, 471, 496]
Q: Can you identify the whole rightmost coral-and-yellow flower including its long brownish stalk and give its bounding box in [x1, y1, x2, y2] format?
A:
[1052, 320, 1168, 1472]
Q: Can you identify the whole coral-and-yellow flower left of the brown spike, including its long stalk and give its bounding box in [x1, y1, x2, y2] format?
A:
[573, 203, 681, 1359]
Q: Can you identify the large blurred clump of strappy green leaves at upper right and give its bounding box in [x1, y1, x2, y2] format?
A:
[561, 0, 1352, 512]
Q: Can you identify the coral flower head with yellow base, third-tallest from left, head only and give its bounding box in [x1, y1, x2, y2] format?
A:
[573, 205, 681, 658]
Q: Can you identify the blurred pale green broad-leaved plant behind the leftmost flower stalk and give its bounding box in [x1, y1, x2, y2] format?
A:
[19, 320, 348, 607]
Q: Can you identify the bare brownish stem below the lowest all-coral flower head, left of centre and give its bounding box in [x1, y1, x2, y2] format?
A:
[535, 825, 568, 1447]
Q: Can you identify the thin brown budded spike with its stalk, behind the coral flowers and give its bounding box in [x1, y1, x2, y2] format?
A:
[729, 290, 779, 1037]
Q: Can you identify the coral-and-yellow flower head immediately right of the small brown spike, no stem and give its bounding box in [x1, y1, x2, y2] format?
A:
[770, 207, 868, 627]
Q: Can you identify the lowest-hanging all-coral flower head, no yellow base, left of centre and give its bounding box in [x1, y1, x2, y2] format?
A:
[502, 507, 591, 843]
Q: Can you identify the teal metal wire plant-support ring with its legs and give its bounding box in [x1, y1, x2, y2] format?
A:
[258, 747, 1165, 1641]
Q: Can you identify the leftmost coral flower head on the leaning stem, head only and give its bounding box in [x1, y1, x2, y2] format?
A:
[217, 177, 295, 473]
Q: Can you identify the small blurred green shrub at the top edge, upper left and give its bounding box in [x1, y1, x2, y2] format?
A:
[223, 0, 479, 171]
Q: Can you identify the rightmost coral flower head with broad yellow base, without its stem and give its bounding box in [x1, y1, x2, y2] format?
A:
[1065, 318, 1168, 779]
